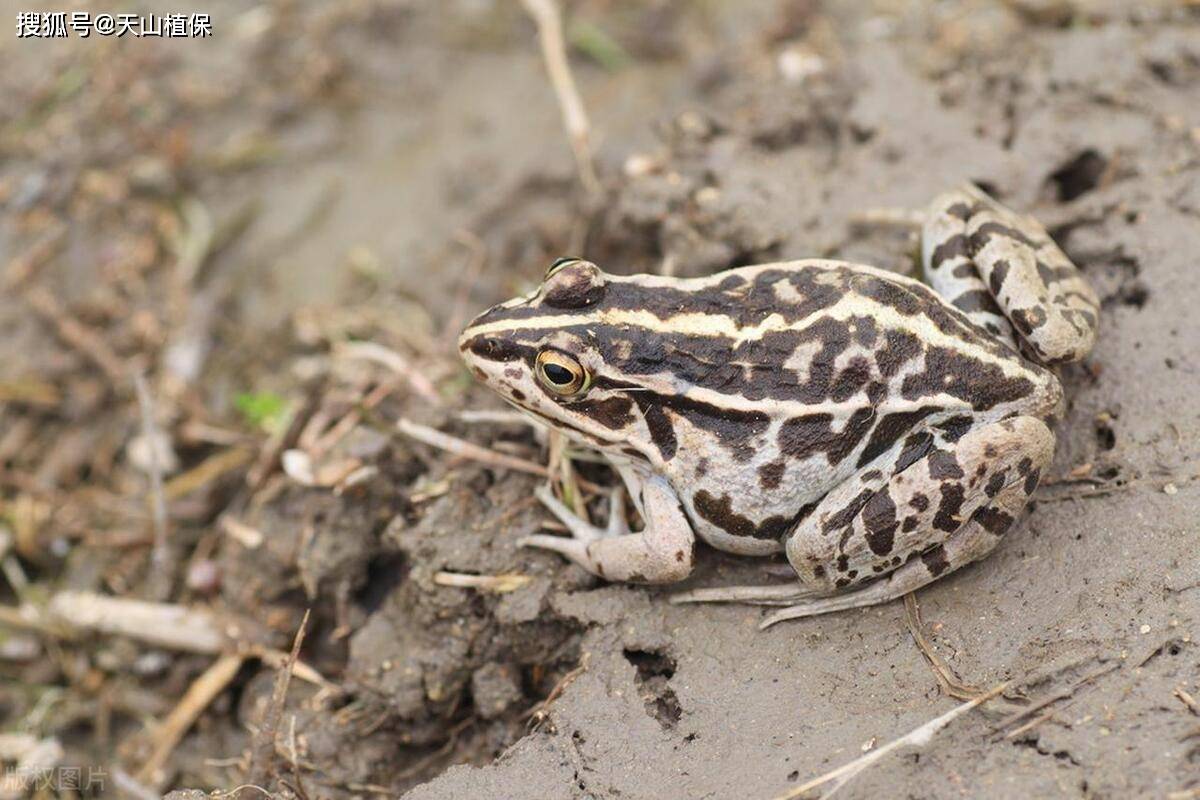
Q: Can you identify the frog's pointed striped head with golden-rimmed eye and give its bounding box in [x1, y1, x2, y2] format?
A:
[458, 258, 658, 461]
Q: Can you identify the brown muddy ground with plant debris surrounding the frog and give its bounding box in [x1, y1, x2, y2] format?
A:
[0, 0, 1200, 800]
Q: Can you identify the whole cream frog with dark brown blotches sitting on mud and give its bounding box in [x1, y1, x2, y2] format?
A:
[458, 184, 1099, 627]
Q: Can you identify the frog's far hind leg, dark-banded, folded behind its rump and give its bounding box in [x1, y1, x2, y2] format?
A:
[922, 185, 1099, 363]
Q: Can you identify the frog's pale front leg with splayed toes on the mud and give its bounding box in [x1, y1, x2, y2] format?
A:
[517, 476, 695, 583]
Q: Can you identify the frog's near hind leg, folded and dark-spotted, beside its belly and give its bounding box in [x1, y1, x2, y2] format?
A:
[772, 416, 1054, 621]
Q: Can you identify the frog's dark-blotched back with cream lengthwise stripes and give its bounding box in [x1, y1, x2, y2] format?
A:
[605, 259, 1058, 417]
